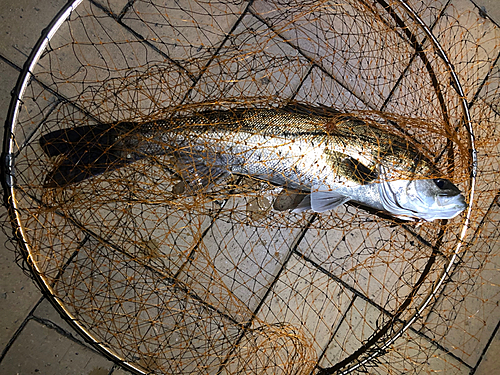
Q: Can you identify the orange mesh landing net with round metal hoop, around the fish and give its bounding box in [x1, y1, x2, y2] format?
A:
[4, 0, 500, 374]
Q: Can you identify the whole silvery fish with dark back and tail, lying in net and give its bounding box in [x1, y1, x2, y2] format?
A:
[39, 103, 467, 221]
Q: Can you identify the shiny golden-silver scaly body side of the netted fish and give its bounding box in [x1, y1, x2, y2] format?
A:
[118, 109, 433, 189]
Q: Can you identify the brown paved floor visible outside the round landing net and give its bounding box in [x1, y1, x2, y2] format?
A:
[0, 0, 500, 375]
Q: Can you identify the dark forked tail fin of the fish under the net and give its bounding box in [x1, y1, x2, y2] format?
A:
[39, 124, 131, 187]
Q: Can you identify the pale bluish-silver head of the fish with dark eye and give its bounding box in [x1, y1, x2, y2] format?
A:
[379, 178, 467, 221]
